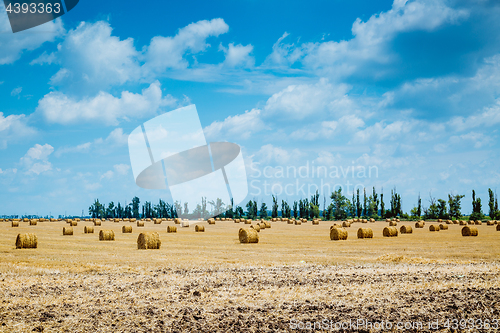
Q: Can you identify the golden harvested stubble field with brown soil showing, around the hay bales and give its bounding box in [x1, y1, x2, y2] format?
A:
[0, 222, 500, 332]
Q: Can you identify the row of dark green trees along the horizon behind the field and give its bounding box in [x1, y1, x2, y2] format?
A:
[89, 187, 500, 220]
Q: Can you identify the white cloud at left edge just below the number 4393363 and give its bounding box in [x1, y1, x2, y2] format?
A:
[0, 10, 64, 65]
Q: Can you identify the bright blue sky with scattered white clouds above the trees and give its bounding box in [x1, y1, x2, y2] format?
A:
[0, 0, 500, 215]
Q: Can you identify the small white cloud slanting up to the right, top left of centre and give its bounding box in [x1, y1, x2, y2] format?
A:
[145, 18, 229, 74]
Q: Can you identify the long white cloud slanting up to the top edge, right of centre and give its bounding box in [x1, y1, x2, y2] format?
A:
[266, 0, 469, 77]
